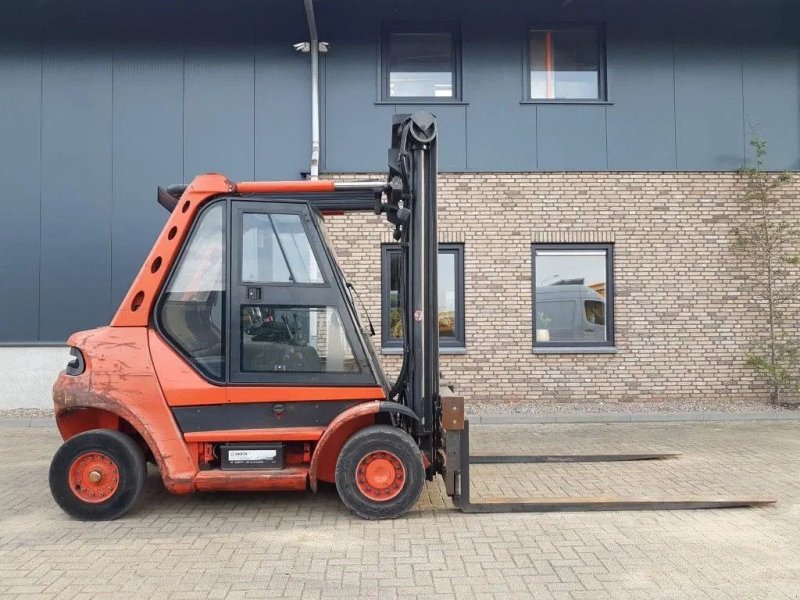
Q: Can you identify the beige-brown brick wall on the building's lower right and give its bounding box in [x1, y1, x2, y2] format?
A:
[328, 173, 800, 402]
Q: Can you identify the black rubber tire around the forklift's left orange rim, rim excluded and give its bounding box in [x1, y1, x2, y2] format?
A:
[50, 429, 147, 521]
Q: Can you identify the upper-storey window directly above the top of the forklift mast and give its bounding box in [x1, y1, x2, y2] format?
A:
[382, 27, 460, 101]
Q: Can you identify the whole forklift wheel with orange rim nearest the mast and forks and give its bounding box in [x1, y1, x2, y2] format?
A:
[336, 425, 425, 519]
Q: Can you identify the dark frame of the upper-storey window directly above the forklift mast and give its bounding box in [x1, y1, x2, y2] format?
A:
[380, 21, 461, 104]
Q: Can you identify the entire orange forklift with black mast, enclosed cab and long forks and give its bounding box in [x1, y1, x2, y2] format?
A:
[49, 113, 771, 520]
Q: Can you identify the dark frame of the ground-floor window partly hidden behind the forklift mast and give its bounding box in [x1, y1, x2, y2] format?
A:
[381, 243, 467, 350]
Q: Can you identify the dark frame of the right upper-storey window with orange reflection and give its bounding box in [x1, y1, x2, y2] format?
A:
[522, 21, 609, 104]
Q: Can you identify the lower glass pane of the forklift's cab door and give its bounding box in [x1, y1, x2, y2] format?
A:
[241, 305, 359, 373]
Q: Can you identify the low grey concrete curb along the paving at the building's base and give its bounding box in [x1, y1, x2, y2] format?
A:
[0, 410, 800, 429]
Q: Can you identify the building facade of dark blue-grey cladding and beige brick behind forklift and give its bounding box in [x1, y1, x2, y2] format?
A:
[0, 0, 800, 406]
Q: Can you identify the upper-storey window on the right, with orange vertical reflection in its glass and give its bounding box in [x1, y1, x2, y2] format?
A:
[528, 27, 605, 100]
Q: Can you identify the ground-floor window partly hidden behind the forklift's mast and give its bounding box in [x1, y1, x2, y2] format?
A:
[381, 244, 466, 348]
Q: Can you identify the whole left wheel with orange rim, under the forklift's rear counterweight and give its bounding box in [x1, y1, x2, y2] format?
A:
[50, 429, 147, 521]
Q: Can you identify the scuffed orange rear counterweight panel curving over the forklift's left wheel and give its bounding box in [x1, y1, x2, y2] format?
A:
[53, 327, 197, 493]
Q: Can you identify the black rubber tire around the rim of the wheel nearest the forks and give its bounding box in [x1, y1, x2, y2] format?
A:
[336, 425, 425, 520]
